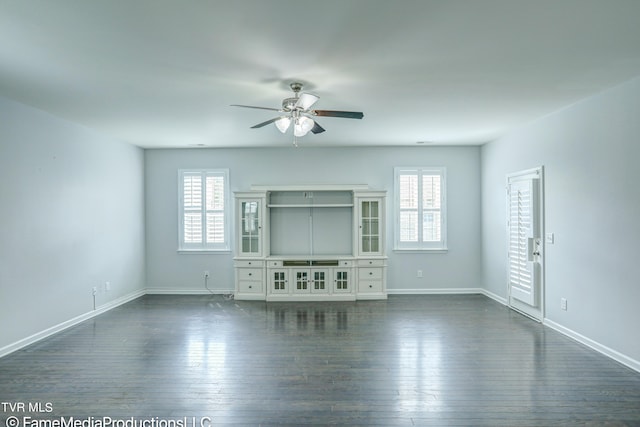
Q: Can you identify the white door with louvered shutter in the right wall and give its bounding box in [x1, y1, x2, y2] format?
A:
[507, 167, 543, 320]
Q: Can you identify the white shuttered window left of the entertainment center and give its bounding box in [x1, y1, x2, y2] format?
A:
[178, 169, 230, 251]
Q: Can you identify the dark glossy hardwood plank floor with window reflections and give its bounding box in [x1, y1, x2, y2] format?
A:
[0, 295, 640, 427]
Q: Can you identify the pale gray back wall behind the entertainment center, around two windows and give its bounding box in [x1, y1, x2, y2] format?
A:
[145, 147, 480, 292]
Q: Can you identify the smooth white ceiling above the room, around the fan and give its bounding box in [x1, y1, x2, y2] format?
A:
[0, 0, 640, 148]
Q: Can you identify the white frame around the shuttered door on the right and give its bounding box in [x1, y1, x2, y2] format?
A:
[505, 166, 546, 323]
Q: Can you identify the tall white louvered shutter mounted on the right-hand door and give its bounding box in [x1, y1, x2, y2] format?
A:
[508, 179, 537, 306]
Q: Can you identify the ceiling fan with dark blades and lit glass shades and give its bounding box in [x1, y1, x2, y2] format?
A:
[231, 82, 364, 146]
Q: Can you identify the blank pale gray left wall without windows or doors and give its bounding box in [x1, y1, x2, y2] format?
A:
[0, 98, 145, 350]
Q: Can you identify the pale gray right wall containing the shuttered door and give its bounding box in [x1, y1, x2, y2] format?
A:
[482, 78, 640, 366]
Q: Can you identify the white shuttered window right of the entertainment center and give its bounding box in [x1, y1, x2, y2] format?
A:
[395, 167, 447, 250]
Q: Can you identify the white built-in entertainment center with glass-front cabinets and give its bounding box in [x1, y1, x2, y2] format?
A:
[234, 185, 387, 301]
